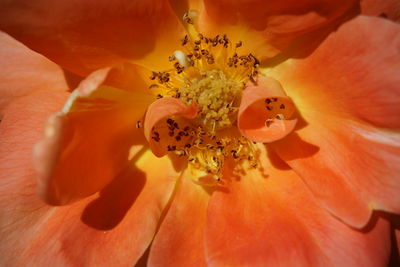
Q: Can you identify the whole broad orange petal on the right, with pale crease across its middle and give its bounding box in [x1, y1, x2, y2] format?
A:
[269, 17, 400, 227]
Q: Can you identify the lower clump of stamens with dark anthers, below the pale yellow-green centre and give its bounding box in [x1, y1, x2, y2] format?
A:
[151, 117, 258, 180]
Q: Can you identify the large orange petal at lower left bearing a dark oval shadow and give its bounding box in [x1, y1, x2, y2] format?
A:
[0, 98, 178, 266]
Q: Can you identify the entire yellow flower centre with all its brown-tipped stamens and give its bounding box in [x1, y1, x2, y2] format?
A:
[150, 12, 259, 184]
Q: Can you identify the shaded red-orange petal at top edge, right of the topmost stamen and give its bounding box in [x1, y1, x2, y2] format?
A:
[201, 0, 358, 58]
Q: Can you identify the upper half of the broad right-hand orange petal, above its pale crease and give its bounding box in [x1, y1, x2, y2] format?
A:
[268, 16, 400, 128]
